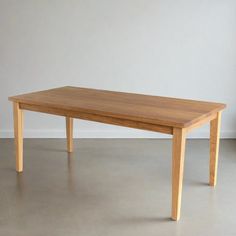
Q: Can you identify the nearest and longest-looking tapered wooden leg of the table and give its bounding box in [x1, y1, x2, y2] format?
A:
[172, 128, 186, 220]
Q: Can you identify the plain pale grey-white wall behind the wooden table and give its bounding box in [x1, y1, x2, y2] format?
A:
[0, 0, 236, 137]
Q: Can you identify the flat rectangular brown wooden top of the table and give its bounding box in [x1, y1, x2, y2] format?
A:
[9, 86, 226, 128]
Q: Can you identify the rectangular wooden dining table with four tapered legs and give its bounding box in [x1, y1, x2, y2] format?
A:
[9, 87, 225, 220]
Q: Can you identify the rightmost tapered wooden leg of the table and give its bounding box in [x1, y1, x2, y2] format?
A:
[209, 112, 221, 186]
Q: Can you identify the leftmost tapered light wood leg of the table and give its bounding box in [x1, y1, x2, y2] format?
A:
[13, 103, 23, 172]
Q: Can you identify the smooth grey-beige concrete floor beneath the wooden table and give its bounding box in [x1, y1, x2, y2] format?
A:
[0, 139, 236, 236]
